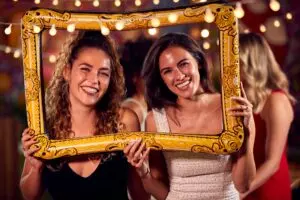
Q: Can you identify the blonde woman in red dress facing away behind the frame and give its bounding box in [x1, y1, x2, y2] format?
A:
[240, 33, 295, 200]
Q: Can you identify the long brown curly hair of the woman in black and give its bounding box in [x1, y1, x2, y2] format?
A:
[45, 31, 124, 139]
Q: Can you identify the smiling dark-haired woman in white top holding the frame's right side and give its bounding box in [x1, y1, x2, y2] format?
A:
[124, 33, 255, 200]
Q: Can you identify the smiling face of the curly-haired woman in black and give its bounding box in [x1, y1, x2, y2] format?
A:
[64, 48, 111, 107]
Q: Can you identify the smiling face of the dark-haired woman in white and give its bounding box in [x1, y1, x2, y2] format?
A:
[159, 46, 201, 99]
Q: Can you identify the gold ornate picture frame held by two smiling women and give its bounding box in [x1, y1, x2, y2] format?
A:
[22, 4, 244, 159]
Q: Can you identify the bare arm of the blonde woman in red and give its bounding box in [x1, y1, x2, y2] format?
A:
[241, 92, 294, 198]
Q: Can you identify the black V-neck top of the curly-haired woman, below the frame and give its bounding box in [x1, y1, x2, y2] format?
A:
[42, 153, 128, 200]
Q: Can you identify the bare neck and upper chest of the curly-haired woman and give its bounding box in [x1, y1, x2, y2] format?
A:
[70, 108, 97, 137]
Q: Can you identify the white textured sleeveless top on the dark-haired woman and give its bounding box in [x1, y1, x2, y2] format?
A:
[153, 109, 239, 200]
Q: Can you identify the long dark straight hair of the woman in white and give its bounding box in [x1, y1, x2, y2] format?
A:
[142, 33, 213, 109]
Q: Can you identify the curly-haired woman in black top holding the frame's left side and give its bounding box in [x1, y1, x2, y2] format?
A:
[20, 31, 145, 199]
